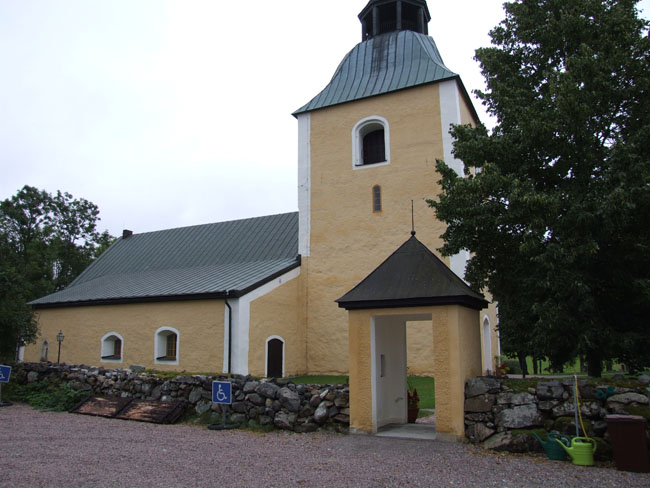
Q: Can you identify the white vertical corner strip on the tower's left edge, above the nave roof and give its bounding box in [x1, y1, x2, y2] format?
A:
[298, 113, 311, 256]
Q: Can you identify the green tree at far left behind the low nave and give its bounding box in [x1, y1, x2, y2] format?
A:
[0, 186, 114, 359]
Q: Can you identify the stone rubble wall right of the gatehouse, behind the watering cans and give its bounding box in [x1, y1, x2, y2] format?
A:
[465, 377, 650, 459]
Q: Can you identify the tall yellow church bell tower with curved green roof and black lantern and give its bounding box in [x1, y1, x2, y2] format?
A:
[293, 0, 488, 374]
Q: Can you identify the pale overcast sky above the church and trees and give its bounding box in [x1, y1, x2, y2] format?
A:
[0, 0, 650, 236]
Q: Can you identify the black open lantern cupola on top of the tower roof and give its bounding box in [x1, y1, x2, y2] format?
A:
[359, 0, 431, 41]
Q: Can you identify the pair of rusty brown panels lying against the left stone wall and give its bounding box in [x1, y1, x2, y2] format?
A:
[70, 396, 185, 424]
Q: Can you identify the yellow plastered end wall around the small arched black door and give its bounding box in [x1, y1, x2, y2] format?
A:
[248, 276, 306, 376]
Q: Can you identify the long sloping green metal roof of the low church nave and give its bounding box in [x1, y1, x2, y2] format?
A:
[32, 212, 300, 307]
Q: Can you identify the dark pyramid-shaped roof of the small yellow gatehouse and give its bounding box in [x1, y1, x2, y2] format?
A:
[336, 235, 488, 310]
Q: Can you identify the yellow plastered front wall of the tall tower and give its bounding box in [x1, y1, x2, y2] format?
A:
[307, 84, 456, 374]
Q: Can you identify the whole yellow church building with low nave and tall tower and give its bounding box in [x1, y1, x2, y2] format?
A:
[24, 0, 498, 384]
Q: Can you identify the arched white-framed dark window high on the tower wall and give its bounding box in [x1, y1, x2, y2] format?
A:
[352, 115, 390, 168]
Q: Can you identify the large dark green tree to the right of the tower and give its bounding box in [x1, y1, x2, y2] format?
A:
[430, 0, 650, 376]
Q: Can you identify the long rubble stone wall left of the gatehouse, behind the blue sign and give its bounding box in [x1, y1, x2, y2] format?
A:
[12, 363, 350, 432]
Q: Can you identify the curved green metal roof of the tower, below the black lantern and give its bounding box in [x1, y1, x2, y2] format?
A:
[293, 30, 458, 115]
